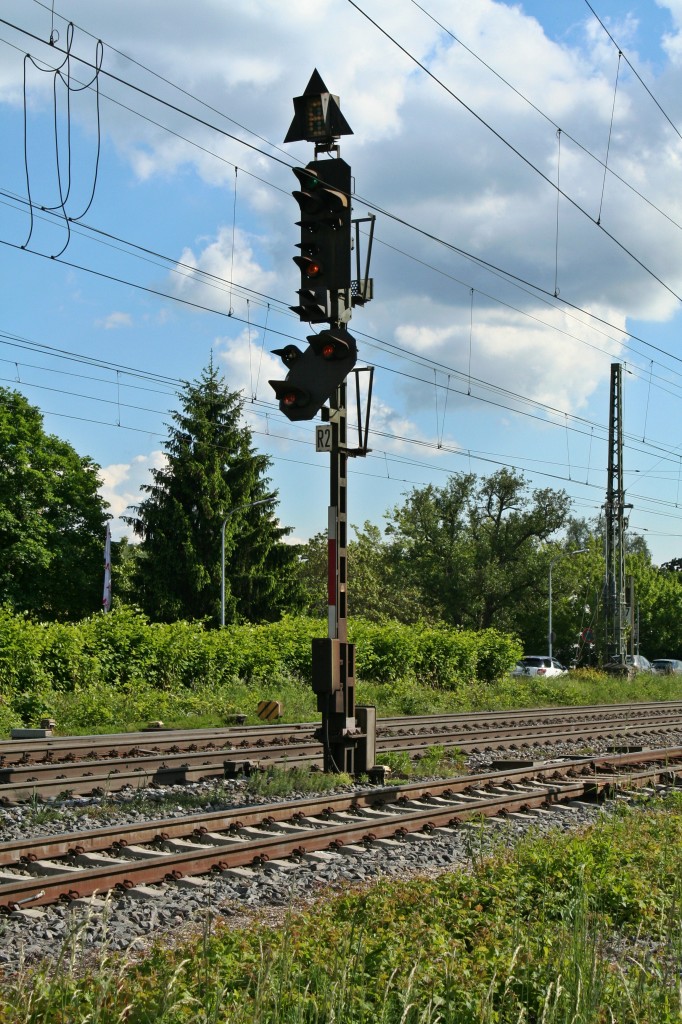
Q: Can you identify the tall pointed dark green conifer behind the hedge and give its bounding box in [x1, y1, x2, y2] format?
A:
[125, 358, 300, 624]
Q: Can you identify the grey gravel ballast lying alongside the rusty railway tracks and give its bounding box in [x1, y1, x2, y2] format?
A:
[0, 735, 682, 974]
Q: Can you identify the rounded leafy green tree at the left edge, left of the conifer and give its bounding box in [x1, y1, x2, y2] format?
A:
[0, 388, 110, 620]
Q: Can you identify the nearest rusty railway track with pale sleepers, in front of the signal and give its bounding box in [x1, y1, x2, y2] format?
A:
[0, 746, 682, 913]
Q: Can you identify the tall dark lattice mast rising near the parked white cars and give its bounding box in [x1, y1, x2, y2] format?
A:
[604, 362, 632, 665]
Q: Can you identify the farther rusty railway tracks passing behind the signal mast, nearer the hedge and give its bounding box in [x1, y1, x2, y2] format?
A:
[0, 701, 682, 805]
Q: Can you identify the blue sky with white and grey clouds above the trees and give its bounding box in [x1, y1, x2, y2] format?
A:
[0, 0, 682, 562]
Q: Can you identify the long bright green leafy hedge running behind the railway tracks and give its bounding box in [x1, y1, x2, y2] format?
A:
[0, 606, 521, 698]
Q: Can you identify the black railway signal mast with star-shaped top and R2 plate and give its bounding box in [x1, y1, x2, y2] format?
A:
[269, 71, 376, 774]
